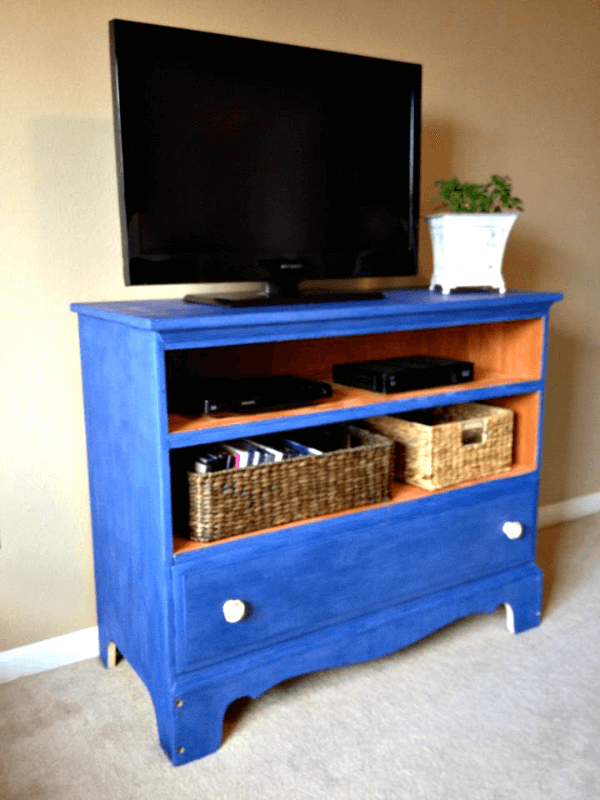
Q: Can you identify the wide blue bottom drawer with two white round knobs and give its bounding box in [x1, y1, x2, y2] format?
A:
[174, 479, 536, 672]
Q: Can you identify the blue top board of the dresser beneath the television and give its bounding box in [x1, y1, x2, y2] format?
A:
[71, 289, 562, 349]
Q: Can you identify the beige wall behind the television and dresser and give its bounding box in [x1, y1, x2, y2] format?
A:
[0, 0, 600, 649]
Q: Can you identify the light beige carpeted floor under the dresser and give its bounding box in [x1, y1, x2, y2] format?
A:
[0, 515, 600, 800]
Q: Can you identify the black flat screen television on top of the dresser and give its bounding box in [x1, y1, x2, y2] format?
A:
[110, 20, 421, 303]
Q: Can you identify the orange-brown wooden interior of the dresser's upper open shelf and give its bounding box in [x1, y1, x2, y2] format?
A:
[167, 319, 543, 433]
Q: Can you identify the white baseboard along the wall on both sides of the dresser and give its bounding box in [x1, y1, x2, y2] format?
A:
[0, 492, 600, 683]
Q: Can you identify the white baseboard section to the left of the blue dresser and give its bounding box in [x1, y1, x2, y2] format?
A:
[0, 628, 99, 683]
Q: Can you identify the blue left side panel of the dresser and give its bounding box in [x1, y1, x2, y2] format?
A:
[80, 317, 173, 752]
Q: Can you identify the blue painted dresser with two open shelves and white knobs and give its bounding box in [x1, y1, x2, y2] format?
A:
[73, 290, 561, 764]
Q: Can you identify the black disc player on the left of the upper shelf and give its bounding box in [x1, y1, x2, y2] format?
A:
[169, 375, 331, 416]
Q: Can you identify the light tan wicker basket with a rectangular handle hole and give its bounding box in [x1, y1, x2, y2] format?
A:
[368, 403, 513, 490]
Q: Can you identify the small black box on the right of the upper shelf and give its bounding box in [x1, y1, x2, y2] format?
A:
[332, 356, 473, 394]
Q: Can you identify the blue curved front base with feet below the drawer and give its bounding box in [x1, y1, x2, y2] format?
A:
[167, 564, 542, 765]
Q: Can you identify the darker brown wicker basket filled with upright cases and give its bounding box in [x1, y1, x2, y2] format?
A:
[188, 428, 394, 542]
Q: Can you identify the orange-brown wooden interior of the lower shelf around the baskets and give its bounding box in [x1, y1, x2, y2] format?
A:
[173, 392, 540, 555]
